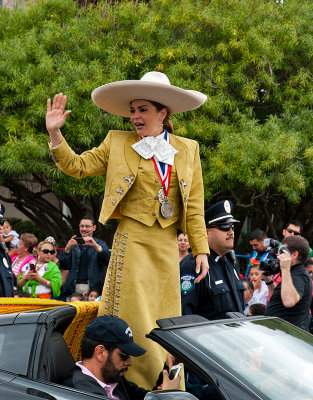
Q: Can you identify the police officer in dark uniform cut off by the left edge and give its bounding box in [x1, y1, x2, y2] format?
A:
[0, 204, 14, 297]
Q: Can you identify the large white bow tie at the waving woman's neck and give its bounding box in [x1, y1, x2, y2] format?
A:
[132, 136, 178, 165]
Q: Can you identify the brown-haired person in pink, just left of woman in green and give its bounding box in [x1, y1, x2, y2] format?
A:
[12, 233, 38, 279]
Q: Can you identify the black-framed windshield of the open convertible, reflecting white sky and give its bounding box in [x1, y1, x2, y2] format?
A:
[148, 313, 313, 400]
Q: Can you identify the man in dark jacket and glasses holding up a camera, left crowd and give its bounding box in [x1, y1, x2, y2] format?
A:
[59, 216, 110, 300]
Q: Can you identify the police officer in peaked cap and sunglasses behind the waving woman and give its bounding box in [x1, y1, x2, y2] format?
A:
[180, 200, 245, 320]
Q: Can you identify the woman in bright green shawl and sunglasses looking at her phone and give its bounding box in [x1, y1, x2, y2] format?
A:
[18, 241, 62, 299]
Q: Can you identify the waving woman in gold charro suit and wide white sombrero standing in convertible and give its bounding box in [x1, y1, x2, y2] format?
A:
[46, 72, 209, 388]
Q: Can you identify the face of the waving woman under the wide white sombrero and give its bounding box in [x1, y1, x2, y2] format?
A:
[130, 100, 167, 136]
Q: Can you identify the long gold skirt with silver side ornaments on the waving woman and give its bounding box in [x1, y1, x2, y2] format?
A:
[99, 217, 181, 390]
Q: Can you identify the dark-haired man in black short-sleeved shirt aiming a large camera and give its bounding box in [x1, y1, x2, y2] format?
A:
[263, 235, 312, 331]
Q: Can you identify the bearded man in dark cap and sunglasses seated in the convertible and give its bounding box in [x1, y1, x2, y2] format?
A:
[63, 315, 180, 400]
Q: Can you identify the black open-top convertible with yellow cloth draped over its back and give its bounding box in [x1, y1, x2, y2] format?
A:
[0, 299, 313, 400]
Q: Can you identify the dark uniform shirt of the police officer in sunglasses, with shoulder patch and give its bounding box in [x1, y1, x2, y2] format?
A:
[180, 250, 244, 320]
